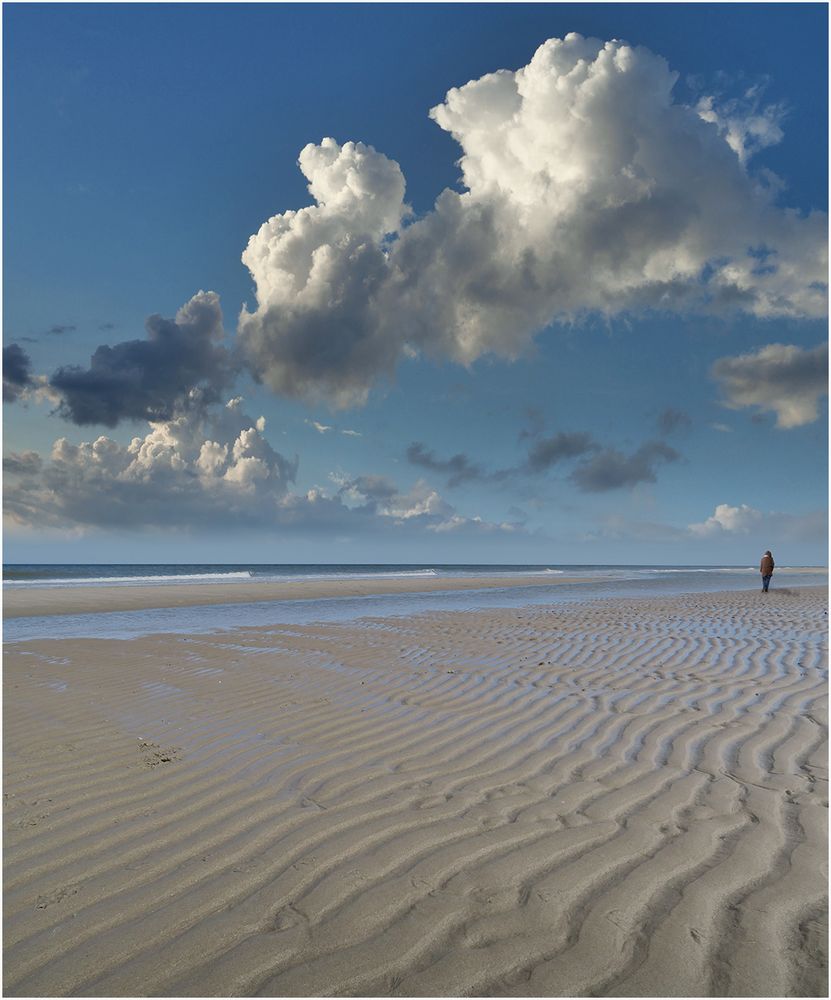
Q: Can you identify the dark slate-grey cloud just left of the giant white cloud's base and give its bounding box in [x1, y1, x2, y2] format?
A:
[49, 292, 235, 427]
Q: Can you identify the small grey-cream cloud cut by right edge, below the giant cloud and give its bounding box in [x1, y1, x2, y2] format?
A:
[711, 344, 828, 430]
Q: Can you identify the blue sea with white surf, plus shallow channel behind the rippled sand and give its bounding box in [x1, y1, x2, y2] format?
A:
[3, 563, 828, 643]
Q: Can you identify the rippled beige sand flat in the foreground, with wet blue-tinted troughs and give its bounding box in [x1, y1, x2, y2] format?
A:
[4, 588, 828, 996]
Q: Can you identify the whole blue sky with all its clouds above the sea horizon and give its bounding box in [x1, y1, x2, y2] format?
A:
[3, 3, 828, 565]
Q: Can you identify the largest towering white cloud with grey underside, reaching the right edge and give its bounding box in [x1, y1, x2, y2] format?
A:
[239, 34, 827, 406]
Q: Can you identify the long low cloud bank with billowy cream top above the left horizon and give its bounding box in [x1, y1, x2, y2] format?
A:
[4, 397, 523, 538]
